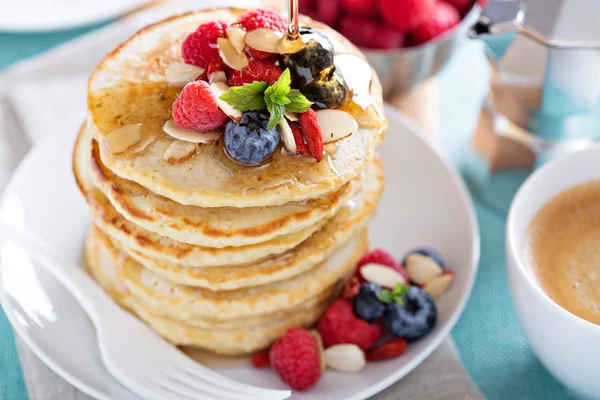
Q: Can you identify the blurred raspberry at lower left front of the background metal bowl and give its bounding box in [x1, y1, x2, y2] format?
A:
[340, 16, 404, 49]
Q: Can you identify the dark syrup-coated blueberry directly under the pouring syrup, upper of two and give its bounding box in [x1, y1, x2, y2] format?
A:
[285, 28, 333, 88]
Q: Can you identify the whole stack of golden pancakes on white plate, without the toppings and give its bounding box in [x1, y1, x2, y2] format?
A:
[73, 9, 385, 354]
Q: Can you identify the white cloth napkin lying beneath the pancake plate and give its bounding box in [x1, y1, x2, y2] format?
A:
[0, 0, 484, 400]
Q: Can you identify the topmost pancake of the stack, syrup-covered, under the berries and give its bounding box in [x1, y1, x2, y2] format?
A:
[88, 9, 386, 208]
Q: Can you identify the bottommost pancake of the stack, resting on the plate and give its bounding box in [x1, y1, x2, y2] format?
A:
[88, 236, 340, 355]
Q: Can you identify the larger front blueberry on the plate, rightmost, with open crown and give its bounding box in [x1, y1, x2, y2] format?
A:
[383, 286, 437, 341]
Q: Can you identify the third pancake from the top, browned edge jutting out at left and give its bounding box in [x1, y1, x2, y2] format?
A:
[73, 130, 327, 267]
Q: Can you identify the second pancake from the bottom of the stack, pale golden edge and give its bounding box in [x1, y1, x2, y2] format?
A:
[86, 228, 367, 322]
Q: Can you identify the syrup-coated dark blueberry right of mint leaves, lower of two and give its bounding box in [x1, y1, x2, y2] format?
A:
[300, 69, 348, 110]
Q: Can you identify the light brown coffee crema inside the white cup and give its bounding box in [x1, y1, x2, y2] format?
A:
[524, 180, 600, 325]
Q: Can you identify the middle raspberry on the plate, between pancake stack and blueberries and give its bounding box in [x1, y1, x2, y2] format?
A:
[317, 299, 382, 350]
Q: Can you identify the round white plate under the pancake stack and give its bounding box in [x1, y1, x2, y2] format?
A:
[0, 106, 479, 400]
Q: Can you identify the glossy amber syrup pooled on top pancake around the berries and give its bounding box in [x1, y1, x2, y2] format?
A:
[88, 82, 360, 195]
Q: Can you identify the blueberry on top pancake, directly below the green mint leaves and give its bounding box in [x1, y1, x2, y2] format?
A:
[224, 111, 281, 165]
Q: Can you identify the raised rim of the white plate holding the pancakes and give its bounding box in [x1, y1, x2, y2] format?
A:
[0, 104, 481, 400]
